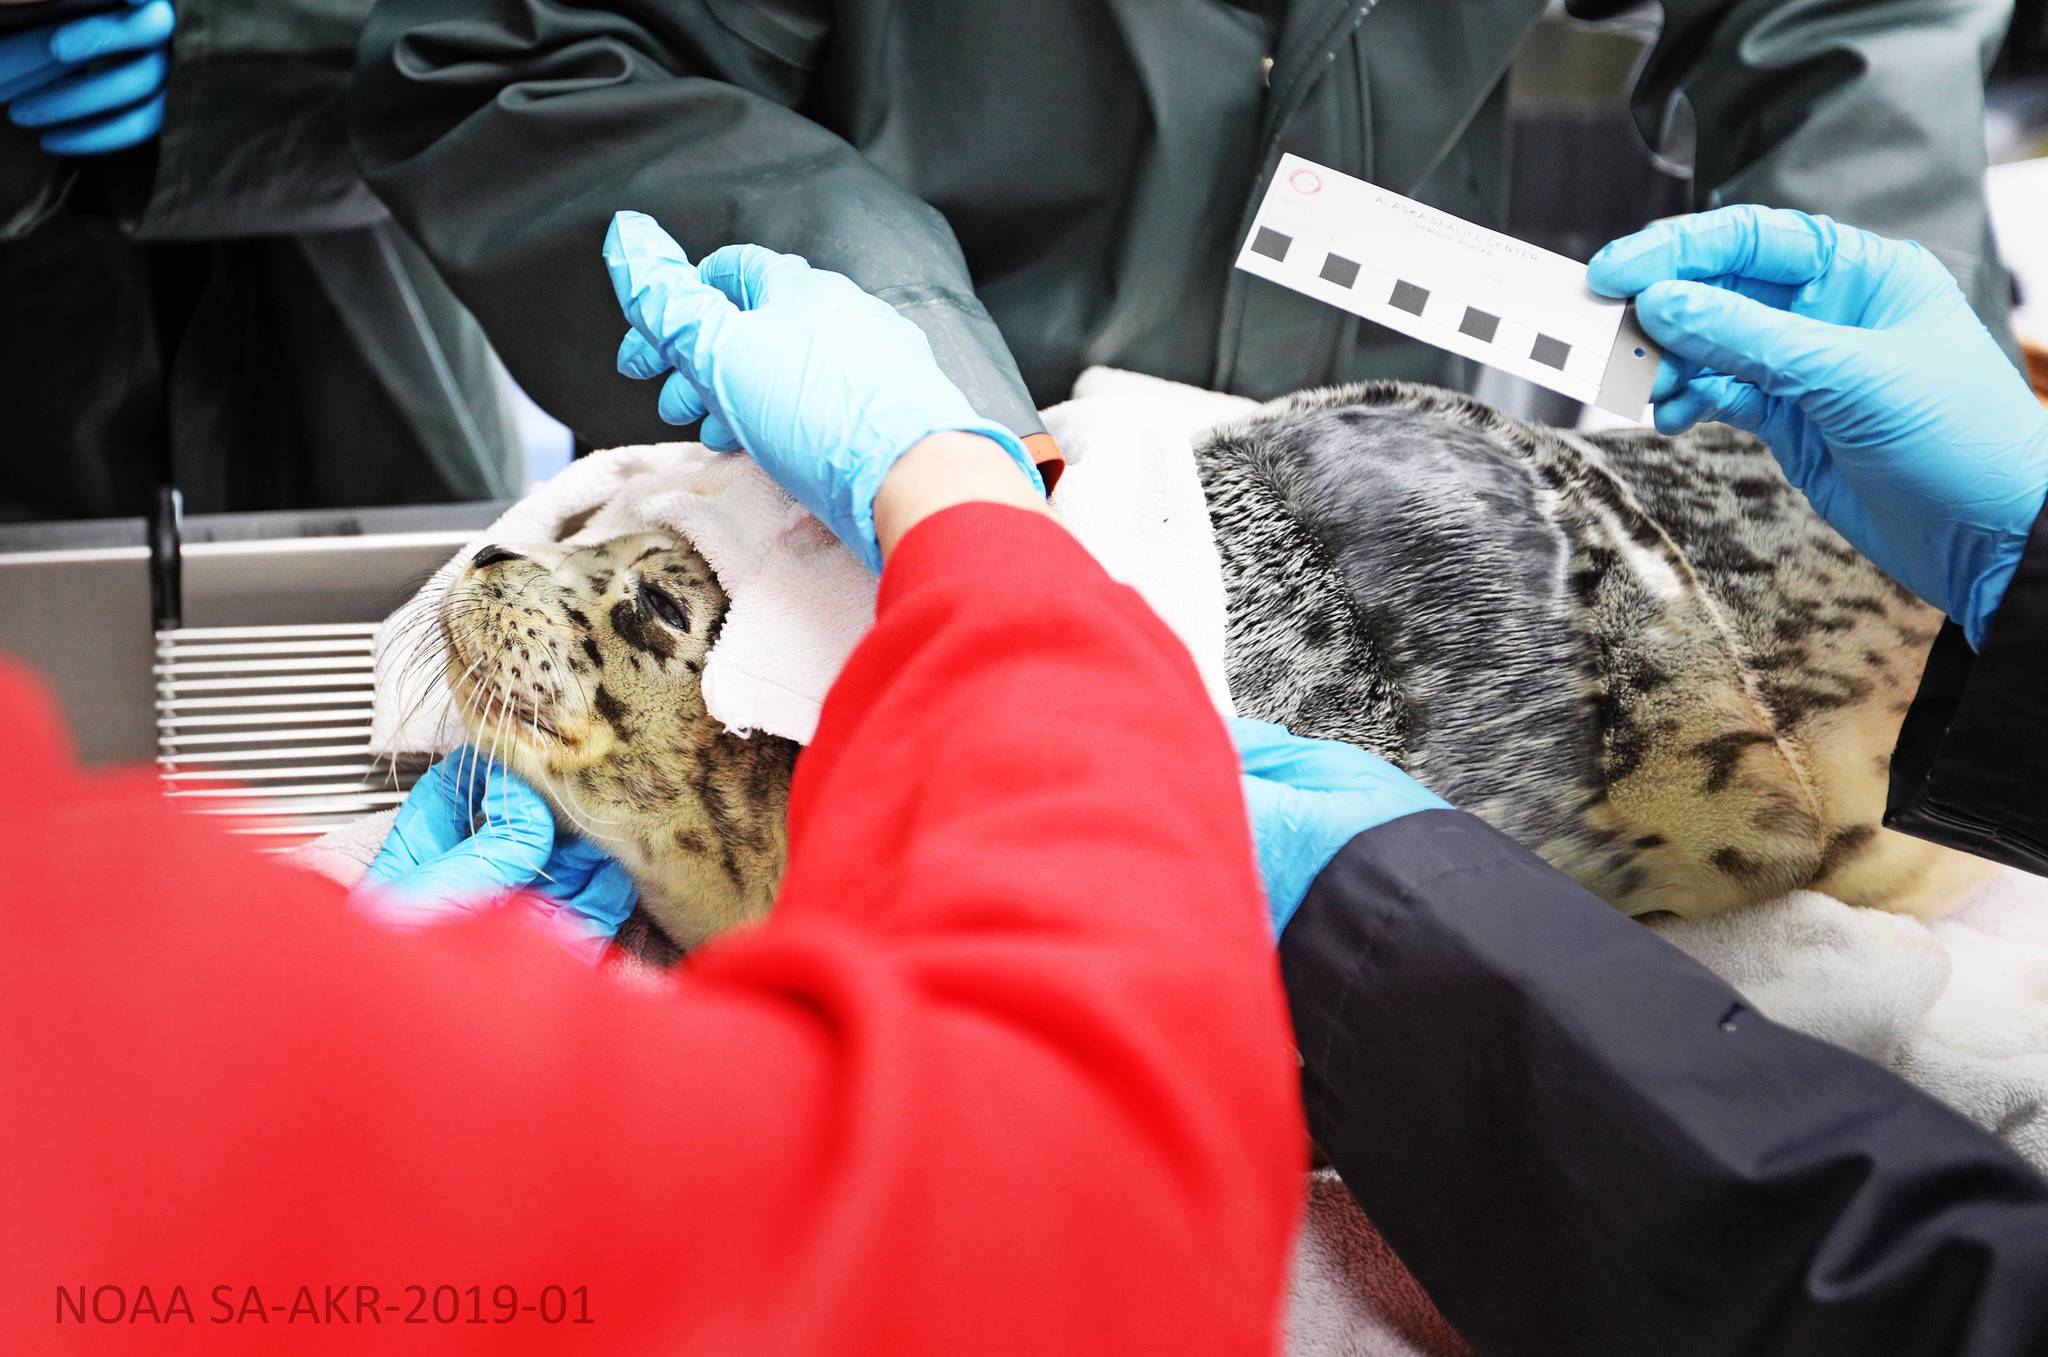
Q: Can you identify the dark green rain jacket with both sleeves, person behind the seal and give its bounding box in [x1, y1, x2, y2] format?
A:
[352, 0, 2011, 444]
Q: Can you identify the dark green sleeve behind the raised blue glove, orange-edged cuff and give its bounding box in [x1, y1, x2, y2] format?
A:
[352, 0, 1040, 446]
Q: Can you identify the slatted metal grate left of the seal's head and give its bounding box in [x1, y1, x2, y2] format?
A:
[154, 622, 426, 851]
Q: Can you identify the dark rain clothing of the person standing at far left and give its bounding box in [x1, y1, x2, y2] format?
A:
[0, 0, 518, 520]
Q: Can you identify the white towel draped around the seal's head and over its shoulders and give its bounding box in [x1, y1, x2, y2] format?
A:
[371, 368, 1251, 753]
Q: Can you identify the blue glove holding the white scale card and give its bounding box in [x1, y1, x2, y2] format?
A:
[1589, 207, 2048, 647]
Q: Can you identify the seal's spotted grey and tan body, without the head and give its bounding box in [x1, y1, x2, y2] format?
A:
[1198, 383, 1972, 915]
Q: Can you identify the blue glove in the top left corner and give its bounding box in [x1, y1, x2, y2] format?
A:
[0, 0, 178, 156]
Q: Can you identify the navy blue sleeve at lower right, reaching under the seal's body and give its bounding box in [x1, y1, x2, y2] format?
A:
[1280, 811, 2048, 1357]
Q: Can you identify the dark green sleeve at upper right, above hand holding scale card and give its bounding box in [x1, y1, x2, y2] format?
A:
[1569, 0, 2013, 346]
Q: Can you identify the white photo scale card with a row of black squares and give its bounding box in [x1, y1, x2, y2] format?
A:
[1237, 156, 1663, 420]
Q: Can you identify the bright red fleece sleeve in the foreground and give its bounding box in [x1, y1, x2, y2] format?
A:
[0, 506, 1305, 1355]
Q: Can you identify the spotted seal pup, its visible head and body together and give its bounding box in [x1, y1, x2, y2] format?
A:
[444, 383, 1968, 958]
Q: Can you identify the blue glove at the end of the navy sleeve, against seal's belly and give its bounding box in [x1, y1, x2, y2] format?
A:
[1231, 716, 1450, 937]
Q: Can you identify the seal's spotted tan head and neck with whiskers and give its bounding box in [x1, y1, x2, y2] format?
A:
[440, 532, 797, 948]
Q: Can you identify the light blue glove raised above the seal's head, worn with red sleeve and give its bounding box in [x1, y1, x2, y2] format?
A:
[604, 213, 1044, 569]
